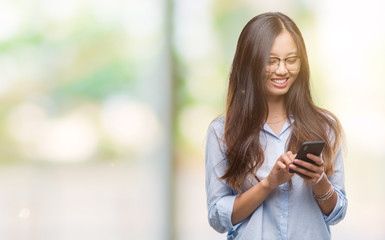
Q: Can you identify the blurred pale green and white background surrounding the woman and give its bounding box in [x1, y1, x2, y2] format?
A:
[0, 0, 385, 240]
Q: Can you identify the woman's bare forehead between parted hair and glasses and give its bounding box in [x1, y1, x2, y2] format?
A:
[270, 30, 297, 57]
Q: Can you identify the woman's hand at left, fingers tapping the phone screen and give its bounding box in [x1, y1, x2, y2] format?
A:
[262, 151, 295, 189]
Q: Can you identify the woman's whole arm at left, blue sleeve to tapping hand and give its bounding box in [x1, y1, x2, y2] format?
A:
[205, 122, 294, 233]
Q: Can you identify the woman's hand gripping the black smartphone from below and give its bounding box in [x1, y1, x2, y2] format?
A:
[289, 153, 325, 185]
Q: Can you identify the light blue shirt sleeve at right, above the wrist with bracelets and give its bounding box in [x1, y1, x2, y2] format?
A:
[324, 148, 348, 225]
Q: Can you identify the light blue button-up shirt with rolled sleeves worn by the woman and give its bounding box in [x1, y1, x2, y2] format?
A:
[205, 117, 348, 240]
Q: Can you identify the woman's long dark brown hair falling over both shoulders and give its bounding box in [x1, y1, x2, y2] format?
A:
[222, 12, 342, 192]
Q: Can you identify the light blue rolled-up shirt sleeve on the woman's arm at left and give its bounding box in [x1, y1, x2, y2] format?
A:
[205, 120, 236, 233]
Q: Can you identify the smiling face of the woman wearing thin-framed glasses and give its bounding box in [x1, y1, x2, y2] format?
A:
[265, 30, 301, 97]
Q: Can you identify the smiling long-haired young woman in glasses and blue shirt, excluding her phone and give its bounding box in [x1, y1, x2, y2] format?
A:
[206, 13, 347, 240]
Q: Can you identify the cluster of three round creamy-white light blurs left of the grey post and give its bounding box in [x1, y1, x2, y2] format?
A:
[6, 96, 161, 163]
